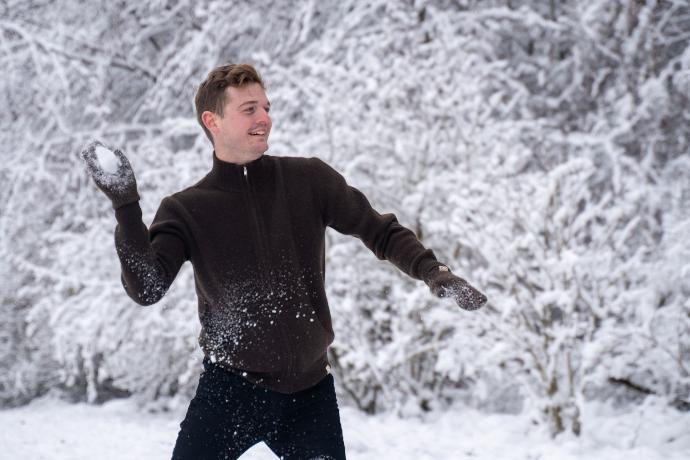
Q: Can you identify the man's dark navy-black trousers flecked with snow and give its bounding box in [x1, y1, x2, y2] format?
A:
[172, 360, 345, 460]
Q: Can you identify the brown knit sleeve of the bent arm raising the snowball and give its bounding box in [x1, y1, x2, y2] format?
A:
[115, 197, 189, 305]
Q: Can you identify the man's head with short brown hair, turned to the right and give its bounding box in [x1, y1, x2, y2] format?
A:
[195, 64, 271, 164]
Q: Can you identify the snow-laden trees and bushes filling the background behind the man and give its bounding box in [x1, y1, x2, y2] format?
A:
[0, 0, 690, 442]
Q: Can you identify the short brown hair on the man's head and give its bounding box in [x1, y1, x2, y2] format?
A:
[194, 64, 266, 144]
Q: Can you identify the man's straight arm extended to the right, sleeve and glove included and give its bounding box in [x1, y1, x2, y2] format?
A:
[314, 159, 486, 310]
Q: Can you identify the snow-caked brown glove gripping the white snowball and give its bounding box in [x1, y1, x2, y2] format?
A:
[81, 141, 139, 209]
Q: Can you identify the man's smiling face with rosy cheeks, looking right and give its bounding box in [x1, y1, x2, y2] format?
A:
[211, 83, 272, 164]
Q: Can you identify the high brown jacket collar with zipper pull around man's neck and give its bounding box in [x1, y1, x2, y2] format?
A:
[206, 150, 272, 191]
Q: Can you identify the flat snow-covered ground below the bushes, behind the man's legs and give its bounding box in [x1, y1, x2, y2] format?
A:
[0, 398, 690, 460]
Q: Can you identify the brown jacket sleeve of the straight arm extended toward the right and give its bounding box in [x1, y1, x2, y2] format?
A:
[313, 158, 442, 280]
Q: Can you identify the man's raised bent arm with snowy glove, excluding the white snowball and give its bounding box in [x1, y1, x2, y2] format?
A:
[81, 142, 189, 305]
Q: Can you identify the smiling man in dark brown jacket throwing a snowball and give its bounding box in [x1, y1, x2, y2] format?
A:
[82, 64, 486, 460]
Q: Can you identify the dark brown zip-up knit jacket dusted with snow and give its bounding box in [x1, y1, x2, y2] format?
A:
[115, 153, 441, 393]
